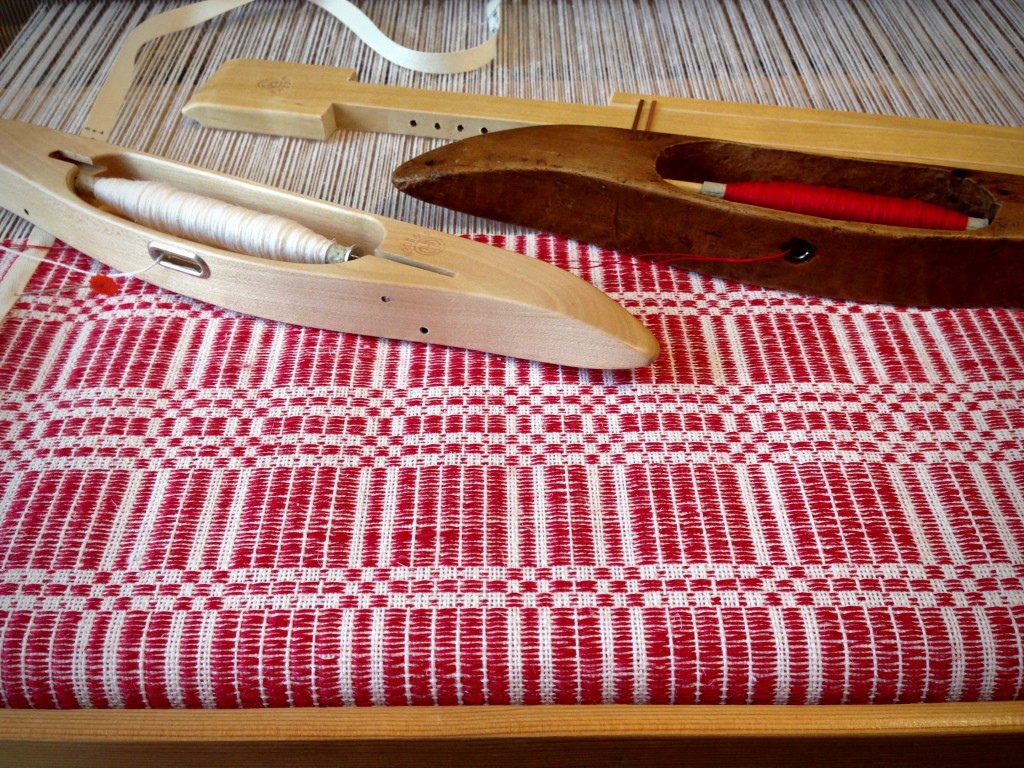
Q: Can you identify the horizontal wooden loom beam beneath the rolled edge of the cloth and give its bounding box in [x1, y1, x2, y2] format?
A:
[0, 3, 1024, 768]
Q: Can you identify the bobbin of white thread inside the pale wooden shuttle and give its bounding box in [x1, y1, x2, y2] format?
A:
[75, 174, 361, 264]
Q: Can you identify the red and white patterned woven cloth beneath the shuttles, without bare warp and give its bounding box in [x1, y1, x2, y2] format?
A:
[0, 237, 1024, 708]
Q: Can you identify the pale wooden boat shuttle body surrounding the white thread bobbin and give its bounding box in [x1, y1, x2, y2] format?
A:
[0, 121, 658, 369]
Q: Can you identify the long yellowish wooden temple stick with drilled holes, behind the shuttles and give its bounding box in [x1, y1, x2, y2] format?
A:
[184, 59, 1024, 174]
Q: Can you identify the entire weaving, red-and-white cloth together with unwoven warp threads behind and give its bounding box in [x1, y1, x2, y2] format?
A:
[0, 0, 1024, 708]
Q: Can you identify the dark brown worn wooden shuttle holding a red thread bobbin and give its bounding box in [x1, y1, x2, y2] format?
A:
[392, 125, 1024, 307]
